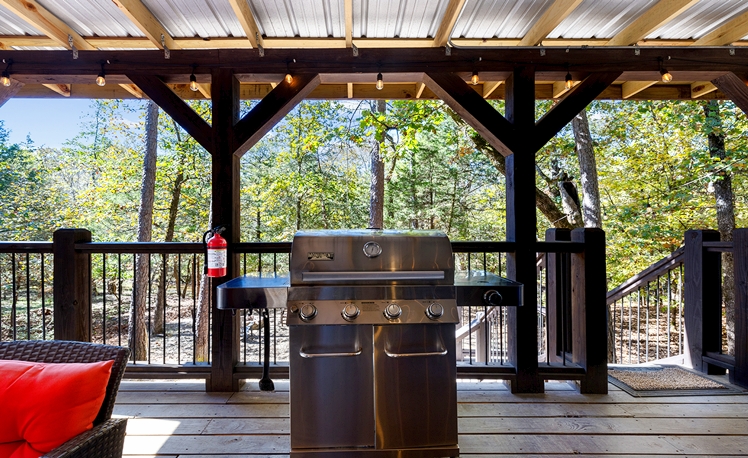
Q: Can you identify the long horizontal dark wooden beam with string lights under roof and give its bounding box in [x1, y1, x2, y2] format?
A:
[0, 46, 748, 75]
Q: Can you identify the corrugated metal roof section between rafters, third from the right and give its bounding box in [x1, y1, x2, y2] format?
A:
[452, 0, 553, 38]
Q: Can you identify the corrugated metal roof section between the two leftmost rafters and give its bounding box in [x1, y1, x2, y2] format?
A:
[37, 0, 143, 37]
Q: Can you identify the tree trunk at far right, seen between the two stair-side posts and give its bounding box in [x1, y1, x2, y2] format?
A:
[703, 100, 735, 355]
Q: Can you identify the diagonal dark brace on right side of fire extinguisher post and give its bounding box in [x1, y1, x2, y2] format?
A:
[234, 74, 320, 157]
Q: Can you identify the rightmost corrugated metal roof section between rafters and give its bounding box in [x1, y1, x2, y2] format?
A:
[647, 0, 748, 40]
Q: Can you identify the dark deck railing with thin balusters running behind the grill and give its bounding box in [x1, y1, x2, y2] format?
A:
[0, 229, 607, 392]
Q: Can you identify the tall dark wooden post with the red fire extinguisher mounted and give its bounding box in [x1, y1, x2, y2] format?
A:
[206, 69, 240, 391]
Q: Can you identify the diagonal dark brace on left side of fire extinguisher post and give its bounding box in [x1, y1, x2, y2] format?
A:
[127, 74, 214, 154]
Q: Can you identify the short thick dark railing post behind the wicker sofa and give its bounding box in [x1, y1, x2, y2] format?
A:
[52, 229, 91, 342]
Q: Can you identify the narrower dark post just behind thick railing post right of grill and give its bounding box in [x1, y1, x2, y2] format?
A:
[545, 229, 572, 362]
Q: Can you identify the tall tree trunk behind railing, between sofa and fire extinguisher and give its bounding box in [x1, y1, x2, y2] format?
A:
[128, 101, 158, 361]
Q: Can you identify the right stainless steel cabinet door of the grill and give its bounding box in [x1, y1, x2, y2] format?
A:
[374, 324, 457, 449]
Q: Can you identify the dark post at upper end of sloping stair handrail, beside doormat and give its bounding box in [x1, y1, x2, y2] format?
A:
[684, 230, 724, 374]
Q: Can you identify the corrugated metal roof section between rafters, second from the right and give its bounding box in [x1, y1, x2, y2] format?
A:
[548, 0, 658, 39]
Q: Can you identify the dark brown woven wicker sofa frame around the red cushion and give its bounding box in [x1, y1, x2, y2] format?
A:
[0, 340, 130, 458]
